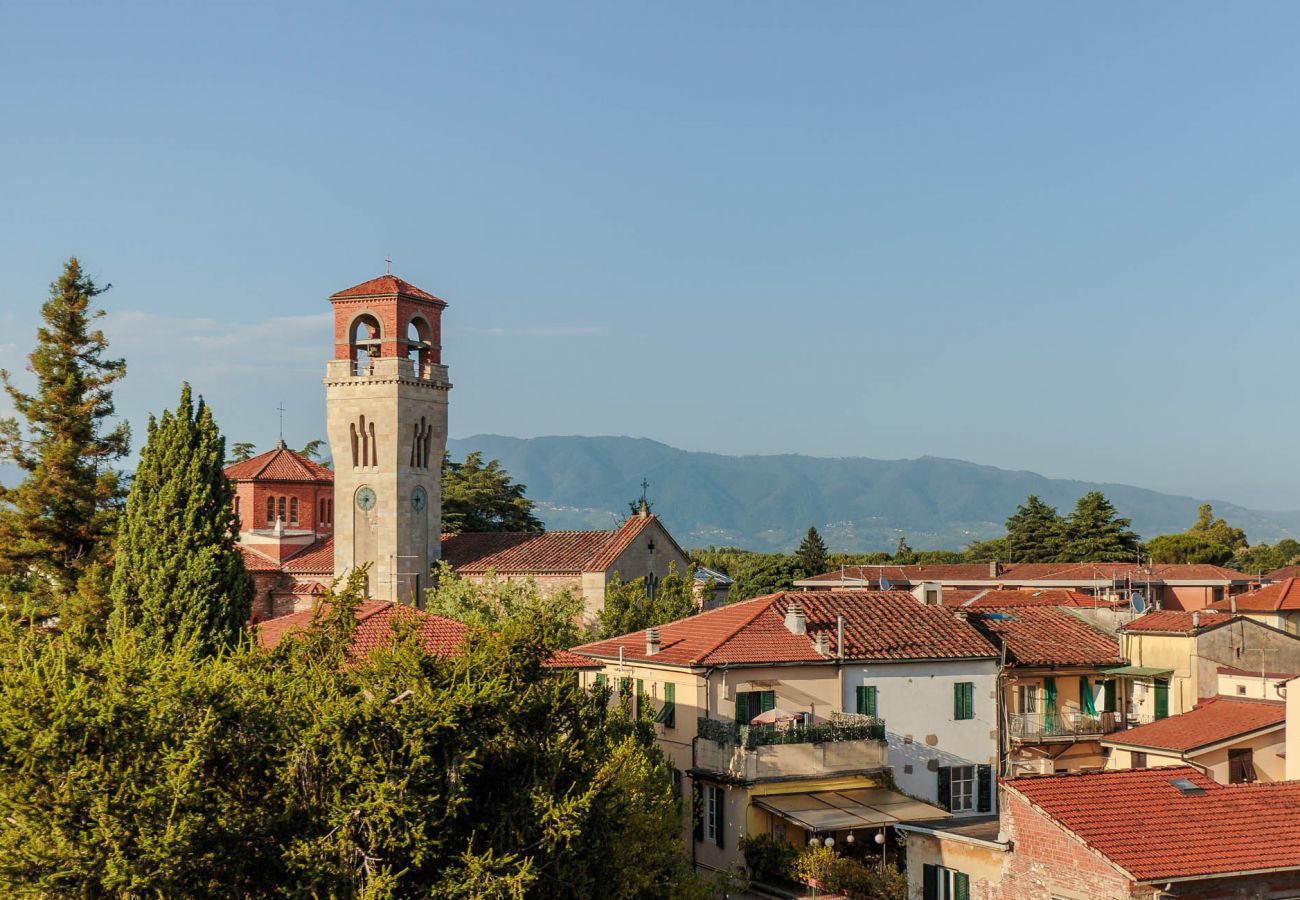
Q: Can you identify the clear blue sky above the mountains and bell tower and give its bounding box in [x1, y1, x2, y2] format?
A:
[0, 0, 1300, 509]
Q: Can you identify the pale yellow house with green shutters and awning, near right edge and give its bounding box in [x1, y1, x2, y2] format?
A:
[1119, 610, 1300, 721]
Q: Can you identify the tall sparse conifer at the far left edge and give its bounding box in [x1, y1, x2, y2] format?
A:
[0, 258, 130, 592]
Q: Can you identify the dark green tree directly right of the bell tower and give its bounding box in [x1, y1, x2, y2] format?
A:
[442, 450, 542, 533]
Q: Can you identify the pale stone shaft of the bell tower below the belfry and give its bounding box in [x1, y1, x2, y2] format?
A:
[325, 358, 451, 602]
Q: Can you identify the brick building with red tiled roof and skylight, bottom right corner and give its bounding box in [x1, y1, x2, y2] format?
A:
[987, 766, 1300, 900]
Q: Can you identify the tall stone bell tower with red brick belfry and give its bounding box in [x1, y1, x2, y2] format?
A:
[325, 274, 451, 603]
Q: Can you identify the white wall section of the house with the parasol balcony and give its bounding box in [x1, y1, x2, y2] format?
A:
[837, 659, 998, 815]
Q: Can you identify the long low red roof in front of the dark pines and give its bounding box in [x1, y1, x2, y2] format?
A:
[802, 562, 1251, 587]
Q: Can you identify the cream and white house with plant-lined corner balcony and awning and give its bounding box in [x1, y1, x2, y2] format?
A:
[575, 592, 997, 869]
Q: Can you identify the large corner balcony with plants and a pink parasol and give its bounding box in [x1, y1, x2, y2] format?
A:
[694, 715, 888, 783]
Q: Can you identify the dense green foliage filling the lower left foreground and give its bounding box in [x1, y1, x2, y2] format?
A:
[0, 579, 701, 897]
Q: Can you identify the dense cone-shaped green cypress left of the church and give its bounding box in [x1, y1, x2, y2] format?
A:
[112, 385, 254, 649]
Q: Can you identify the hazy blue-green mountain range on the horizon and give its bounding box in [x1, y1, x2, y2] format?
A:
[447, 434, 1300, 551]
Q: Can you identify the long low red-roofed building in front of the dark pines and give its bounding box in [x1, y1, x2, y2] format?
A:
[794, 562, 1253, 610]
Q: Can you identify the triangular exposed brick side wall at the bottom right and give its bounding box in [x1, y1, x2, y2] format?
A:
[996, 789, 1149, 900]
